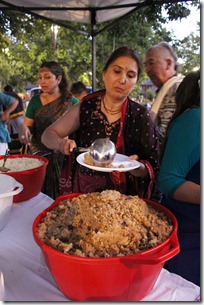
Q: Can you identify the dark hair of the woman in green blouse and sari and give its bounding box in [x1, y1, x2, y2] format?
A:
[40, 61, 72, 99]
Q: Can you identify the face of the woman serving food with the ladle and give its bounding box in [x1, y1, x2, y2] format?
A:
[103, 56, 138, 100]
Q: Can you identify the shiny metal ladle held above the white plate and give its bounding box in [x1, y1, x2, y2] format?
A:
[73, 138, 116, 165]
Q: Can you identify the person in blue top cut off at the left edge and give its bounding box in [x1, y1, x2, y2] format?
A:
[0, 92, 18, 155]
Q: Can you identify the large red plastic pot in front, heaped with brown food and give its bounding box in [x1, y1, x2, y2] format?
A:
[33, 194, 180, 301]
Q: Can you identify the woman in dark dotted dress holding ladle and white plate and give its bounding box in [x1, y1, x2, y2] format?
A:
[41, 46, 159, 198]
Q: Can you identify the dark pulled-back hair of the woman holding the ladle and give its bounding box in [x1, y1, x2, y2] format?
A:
[103, 46, 143, 81]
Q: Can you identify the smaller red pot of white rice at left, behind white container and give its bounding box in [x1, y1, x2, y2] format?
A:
[0, 154, 48, 202]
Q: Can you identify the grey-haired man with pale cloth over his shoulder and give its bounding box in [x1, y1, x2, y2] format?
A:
[144, 42, 183, 145]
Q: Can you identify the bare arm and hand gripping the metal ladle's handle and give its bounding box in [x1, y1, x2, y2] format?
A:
[41, 104, 80, 154]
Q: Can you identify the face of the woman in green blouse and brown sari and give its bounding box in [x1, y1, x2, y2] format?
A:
[38, 68, 62, 94]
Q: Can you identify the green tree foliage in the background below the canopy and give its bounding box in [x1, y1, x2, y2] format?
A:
[0, 0, 200, 91]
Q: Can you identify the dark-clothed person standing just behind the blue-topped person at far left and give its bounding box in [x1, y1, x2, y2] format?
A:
[4, 85, 24, 153]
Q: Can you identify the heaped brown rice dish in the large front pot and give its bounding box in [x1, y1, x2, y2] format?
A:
[37, 190, 173, 257]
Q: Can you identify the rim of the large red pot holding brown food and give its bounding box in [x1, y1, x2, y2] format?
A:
[32, 193, 178, 263]
